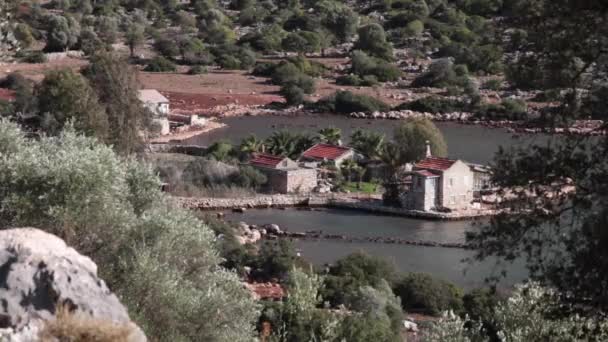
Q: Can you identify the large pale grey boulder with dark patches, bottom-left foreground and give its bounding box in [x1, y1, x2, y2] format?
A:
[0, 228, 146, 342]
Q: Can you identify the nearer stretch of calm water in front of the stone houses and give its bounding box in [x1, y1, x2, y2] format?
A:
[221, 209, 526, 288]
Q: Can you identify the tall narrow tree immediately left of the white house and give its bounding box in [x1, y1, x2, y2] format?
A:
[84, 52, 150, 153]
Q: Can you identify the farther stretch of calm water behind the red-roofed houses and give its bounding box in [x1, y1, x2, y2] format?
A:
[186, 115, 546, 163]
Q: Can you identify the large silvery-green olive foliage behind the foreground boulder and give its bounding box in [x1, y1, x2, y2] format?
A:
[0, 121, 258, 341]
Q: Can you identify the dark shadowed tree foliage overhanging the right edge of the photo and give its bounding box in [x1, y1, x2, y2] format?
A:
[467, 0, 608, 314]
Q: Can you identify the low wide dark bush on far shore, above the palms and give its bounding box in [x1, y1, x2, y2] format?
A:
[313, 91, 390, 114]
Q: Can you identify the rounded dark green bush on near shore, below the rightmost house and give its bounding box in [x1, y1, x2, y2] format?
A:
[394, 273, 463, 316]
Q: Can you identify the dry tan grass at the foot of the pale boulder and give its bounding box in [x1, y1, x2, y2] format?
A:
[40, 307, 136, 342]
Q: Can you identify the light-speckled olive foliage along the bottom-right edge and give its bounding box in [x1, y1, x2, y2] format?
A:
[422, 283, 608, 342]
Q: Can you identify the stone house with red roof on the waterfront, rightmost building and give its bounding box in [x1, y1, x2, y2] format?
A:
[402, 156, 475, 211]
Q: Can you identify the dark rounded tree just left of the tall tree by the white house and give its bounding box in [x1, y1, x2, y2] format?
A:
[35, 69, 108, 138]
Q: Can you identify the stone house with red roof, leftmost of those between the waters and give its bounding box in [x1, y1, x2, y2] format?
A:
[249, 153, 317, 194]
